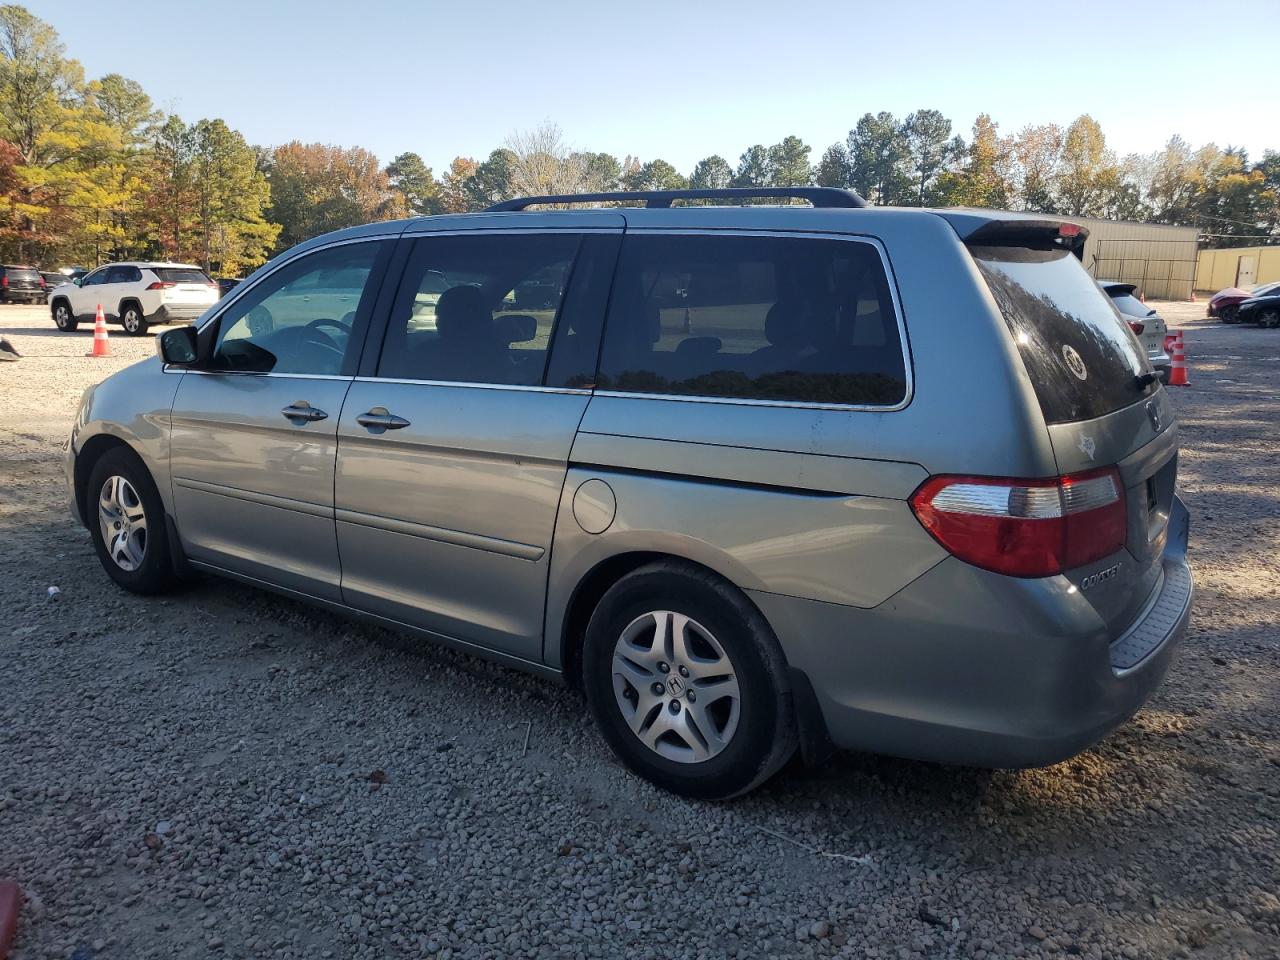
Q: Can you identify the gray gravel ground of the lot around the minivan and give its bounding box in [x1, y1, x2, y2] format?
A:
[0, 305, 1280, 960]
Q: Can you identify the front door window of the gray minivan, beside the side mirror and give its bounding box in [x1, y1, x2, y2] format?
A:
[210, 241, 381, 375]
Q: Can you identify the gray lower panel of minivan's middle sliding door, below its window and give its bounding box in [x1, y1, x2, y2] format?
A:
[337, 379, 589, 659]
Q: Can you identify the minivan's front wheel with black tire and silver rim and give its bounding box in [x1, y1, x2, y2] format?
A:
[84, 447, 177, 594]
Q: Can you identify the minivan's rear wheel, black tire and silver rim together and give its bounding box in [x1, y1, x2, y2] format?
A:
[582, 561, 796, 800]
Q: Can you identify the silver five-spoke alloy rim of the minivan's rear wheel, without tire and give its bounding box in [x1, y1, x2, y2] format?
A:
[613, 611, 741, 763]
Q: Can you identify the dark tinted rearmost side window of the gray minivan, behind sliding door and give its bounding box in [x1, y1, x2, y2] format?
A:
[598, 234, 906, 406]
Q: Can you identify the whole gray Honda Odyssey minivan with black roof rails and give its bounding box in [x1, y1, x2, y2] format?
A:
[67, 188, 1193, 797]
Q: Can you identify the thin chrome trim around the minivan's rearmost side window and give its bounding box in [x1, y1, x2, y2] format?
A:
[604, 227, 915, 413]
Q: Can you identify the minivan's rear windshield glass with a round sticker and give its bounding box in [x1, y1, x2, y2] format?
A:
[970, 247, 1156, 424]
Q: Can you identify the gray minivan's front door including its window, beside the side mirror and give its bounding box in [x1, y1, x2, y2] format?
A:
[170, 241, 390, 600]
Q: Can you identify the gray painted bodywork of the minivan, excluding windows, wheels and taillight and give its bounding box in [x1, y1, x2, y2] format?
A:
[68, 200, 1192, 765]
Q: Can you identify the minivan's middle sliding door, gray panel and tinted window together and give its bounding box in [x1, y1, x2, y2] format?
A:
[335, 232, 617, 660]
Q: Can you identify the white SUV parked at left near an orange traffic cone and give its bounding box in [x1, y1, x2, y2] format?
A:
[49, 262, 219, 337]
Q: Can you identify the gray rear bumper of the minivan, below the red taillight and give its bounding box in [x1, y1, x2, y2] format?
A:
[753, 500, 1193, 767]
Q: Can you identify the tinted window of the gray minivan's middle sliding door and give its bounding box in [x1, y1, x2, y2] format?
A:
[378, 233, 581, 385]
